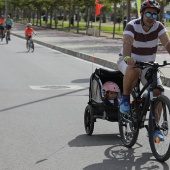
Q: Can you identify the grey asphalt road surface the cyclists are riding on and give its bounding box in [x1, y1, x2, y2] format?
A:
[0, 36, 170, 170]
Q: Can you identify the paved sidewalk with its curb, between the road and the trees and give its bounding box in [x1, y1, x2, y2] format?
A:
[11, 23, 170, 87]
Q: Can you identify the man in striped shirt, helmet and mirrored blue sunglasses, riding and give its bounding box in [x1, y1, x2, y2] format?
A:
[117, 0, 170, 140]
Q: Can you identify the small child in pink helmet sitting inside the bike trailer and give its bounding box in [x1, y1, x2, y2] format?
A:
[103, 81, 120, 106]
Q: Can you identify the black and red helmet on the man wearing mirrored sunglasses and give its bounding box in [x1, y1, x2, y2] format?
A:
[140, 0, 161, 14]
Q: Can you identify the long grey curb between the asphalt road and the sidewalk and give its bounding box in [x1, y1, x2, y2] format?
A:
[11, 33, 170, 87]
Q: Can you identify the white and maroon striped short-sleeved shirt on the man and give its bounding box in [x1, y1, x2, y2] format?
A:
[120, 19, 166, 61]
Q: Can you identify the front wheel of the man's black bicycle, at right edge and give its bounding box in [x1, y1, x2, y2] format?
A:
[149, 95, 170, 162]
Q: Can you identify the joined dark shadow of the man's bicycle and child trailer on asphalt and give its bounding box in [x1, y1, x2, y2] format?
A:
[68, 134, 169, 170]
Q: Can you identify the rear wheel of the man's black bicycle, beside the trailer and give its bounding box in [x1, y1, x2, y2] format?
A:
[119, 92, 140, 148]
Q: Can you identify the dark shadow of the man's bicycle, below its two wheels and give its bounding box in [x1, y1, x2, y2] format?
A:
[83, 145, 169, 170]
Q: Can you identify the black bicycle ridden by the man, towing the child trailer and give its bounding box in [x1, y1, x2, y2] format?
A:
[118, 61, 170, 162]
